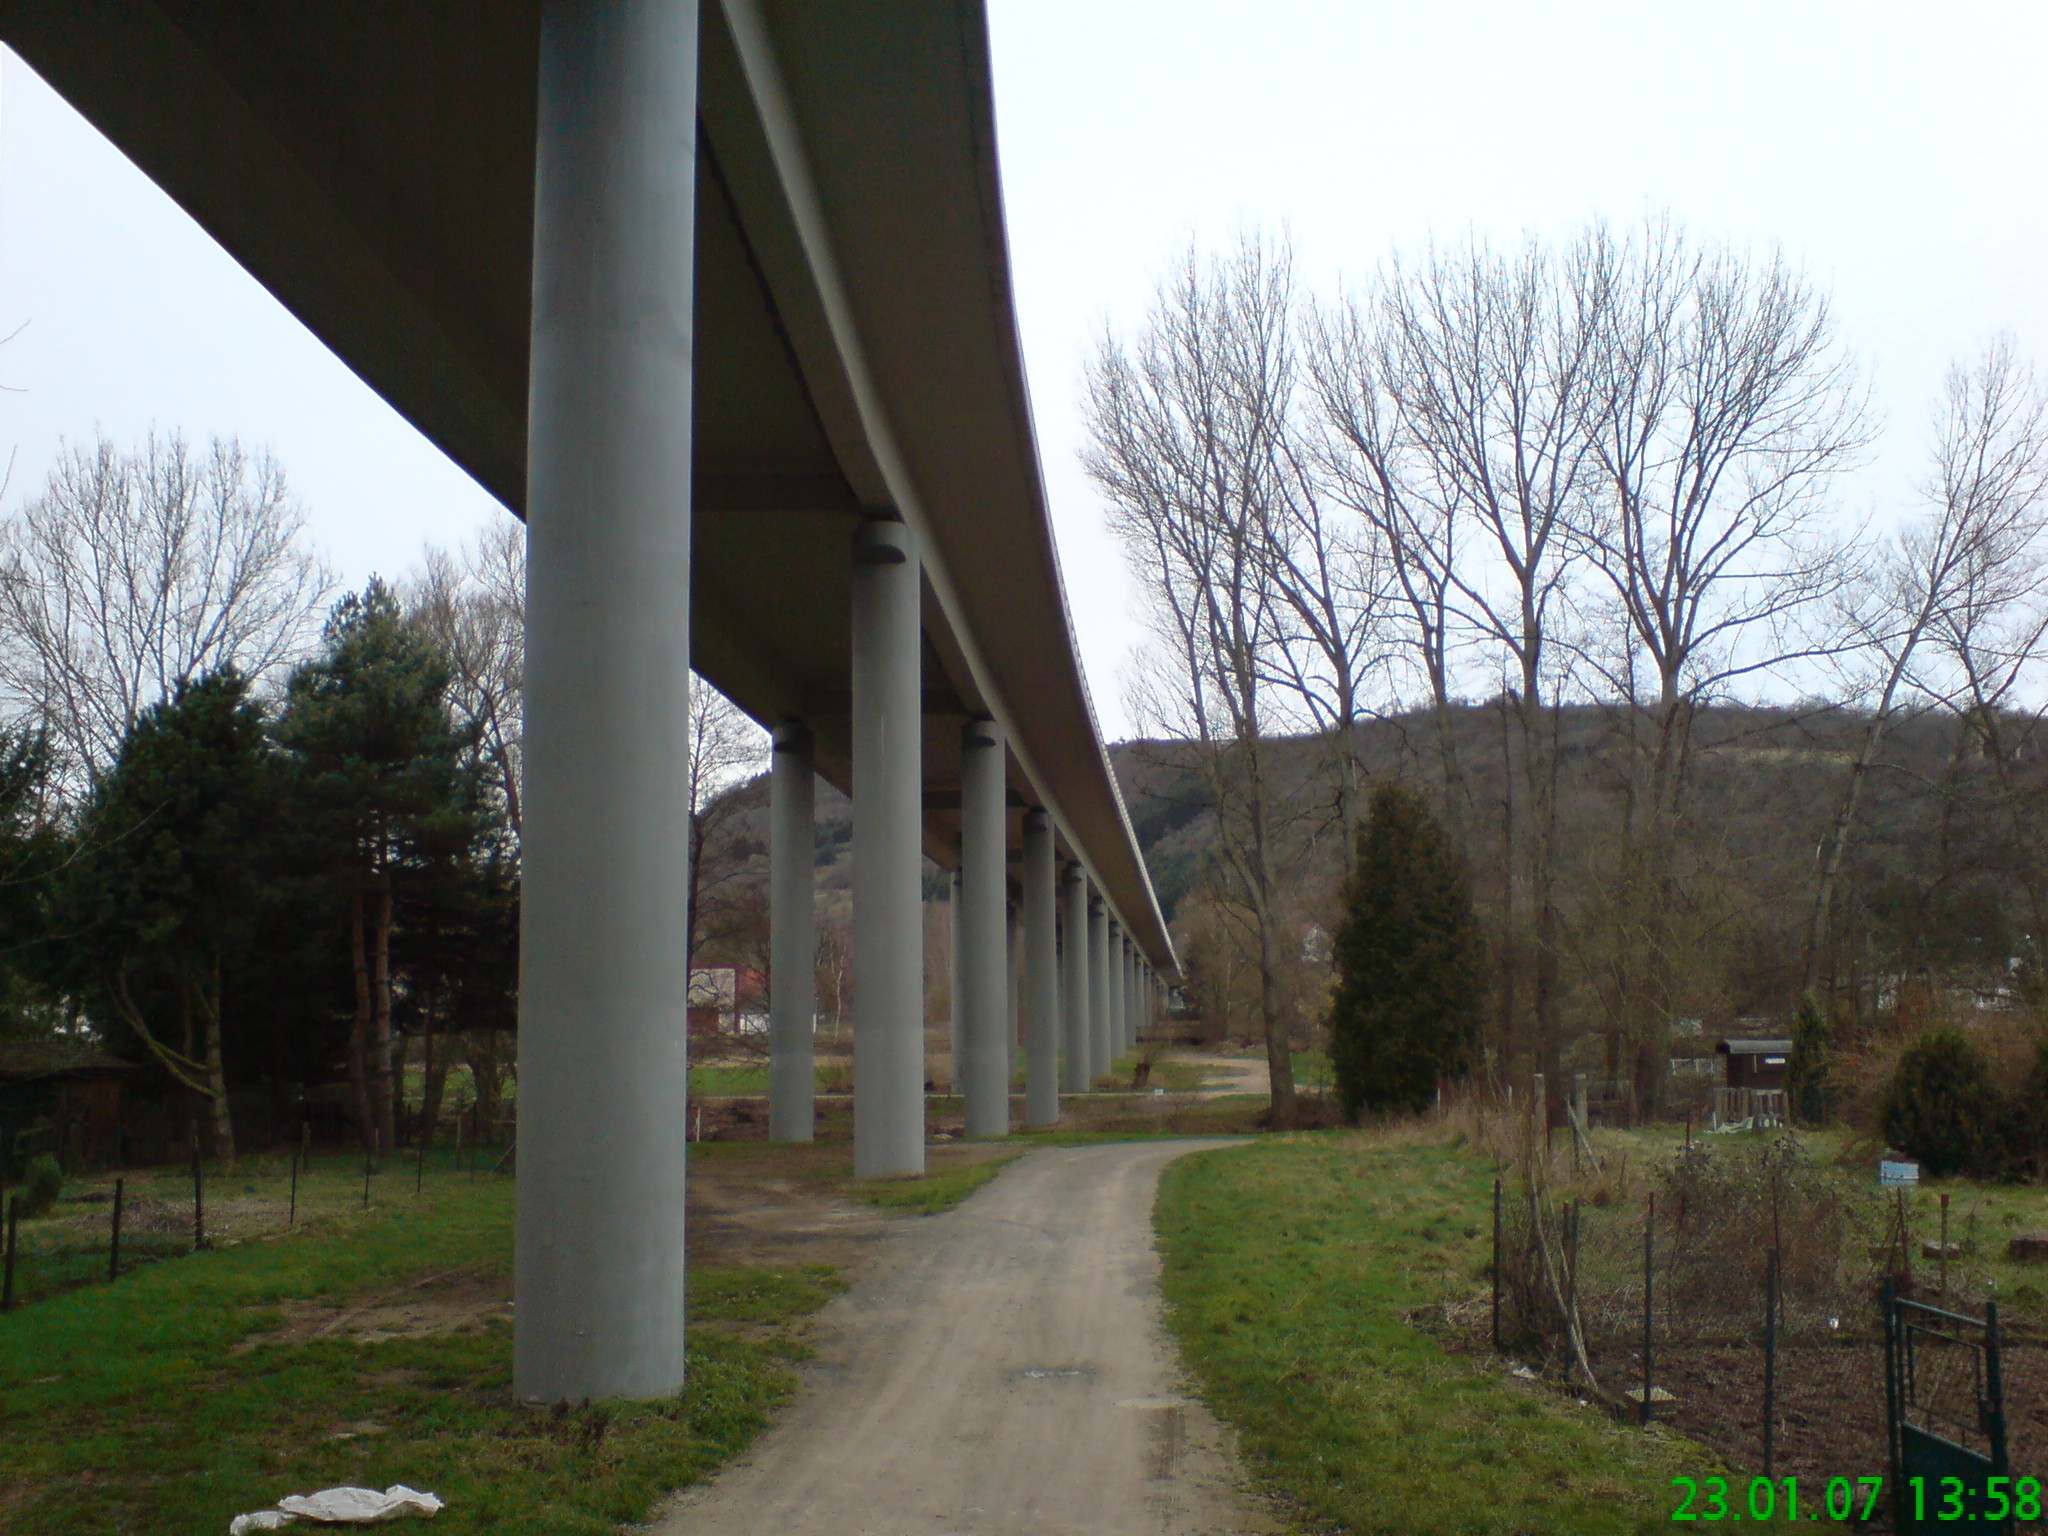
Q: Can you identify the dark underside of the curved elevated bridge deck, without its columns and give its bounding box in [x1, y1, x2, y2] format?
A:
[0, 0, 1169, 937]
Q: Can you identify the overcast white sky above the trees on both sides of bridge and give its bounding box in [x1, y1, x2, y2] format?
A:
[0, 0, 2048, 735]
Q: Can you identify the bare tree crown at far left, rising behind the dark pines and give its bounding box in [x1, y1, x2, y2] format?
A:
[0, 434, 332, 788]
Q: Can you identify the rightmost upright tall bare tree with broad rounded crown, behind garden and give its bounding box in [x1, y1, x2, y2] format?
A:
[1567, 219, 1870, 1112]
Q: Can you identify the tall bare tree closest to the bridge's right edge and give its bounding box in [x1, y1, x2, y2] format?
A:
[1085, 238, 1298, 1126]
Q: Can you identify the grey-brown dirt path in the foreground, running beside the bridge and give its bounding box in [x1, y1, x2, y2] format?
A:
[653, 1141, 1274, 1536]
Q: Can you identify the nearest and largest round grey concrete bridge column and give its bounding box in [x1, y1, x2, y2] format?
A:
[512, 0, 696, 1403]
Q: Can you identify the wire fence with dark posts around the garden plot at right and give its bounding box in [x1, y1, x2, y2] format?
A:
[1493, 1137, 2048, 1530]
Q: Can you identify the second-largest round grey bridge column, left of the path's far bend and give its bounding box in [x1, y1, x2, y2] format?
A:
[852, 518, 924, 1180]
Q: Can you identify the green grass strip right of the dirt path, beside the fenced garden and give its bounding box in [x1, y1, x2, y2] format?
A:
[1155, 1133, 1769, 1536]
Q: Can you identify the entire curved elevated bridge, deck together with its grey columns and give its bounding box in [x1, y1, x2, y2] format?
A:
[0, 0, 1174, 1401]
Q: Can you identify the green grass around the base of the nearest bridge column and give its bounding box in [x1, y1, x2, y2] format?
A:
[0, 1178, 838, 1536]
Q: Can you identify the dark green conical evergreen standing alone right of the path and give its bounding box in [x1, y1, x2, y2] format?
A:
[1329, 782, 1481, 1122]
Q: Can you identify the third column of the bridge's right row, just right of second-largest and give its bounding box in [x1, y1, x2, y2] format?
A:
[952, 721, 1010, 1137]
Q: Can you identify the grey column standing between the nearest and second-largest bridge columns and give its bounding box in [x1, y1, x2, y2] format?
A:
[768, 721, 817, 1141]
